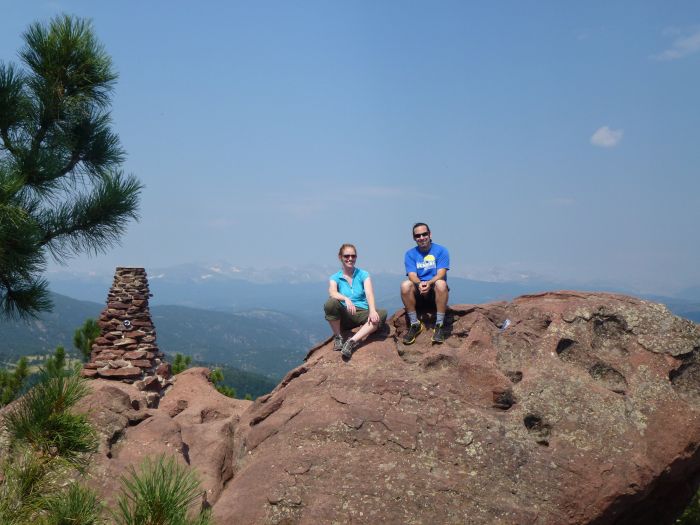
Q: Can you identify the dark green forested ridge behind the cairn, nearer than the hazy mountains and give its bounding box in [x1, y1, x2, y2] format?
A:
[0, 293, 316, 380]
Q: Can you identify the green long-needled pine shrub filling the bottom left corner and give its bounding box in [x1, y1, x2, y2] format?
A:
[0, 364, 101, 525]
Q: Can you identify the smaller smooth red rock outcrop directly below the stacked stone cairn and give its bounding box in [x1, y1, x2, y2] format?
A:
[77, 368, 252, 504]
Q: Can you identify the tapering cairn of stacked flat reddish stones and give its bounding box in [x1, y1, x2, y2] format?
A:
[82, 267, 171, 393]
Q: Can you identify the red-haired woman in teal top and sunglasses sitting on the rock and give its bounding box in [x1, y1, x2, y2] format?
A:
[323, 244, 386, 358]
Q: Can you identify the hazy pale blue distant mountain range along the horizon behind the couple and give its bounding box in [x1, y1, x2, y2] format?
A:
[48, 263, 700, 322]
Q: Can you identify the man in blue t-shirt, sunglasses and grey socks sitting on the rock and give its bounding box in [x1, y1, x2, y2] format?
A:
[401, 222, 450, 345]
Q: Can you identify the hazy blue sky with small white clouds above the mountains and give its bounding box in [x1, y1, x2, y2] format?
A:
[0, 0, 700, 293]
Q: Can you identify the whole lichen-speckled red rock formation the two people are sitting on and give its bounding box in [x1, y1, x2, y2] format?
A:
[65, 292, 700, 525]
